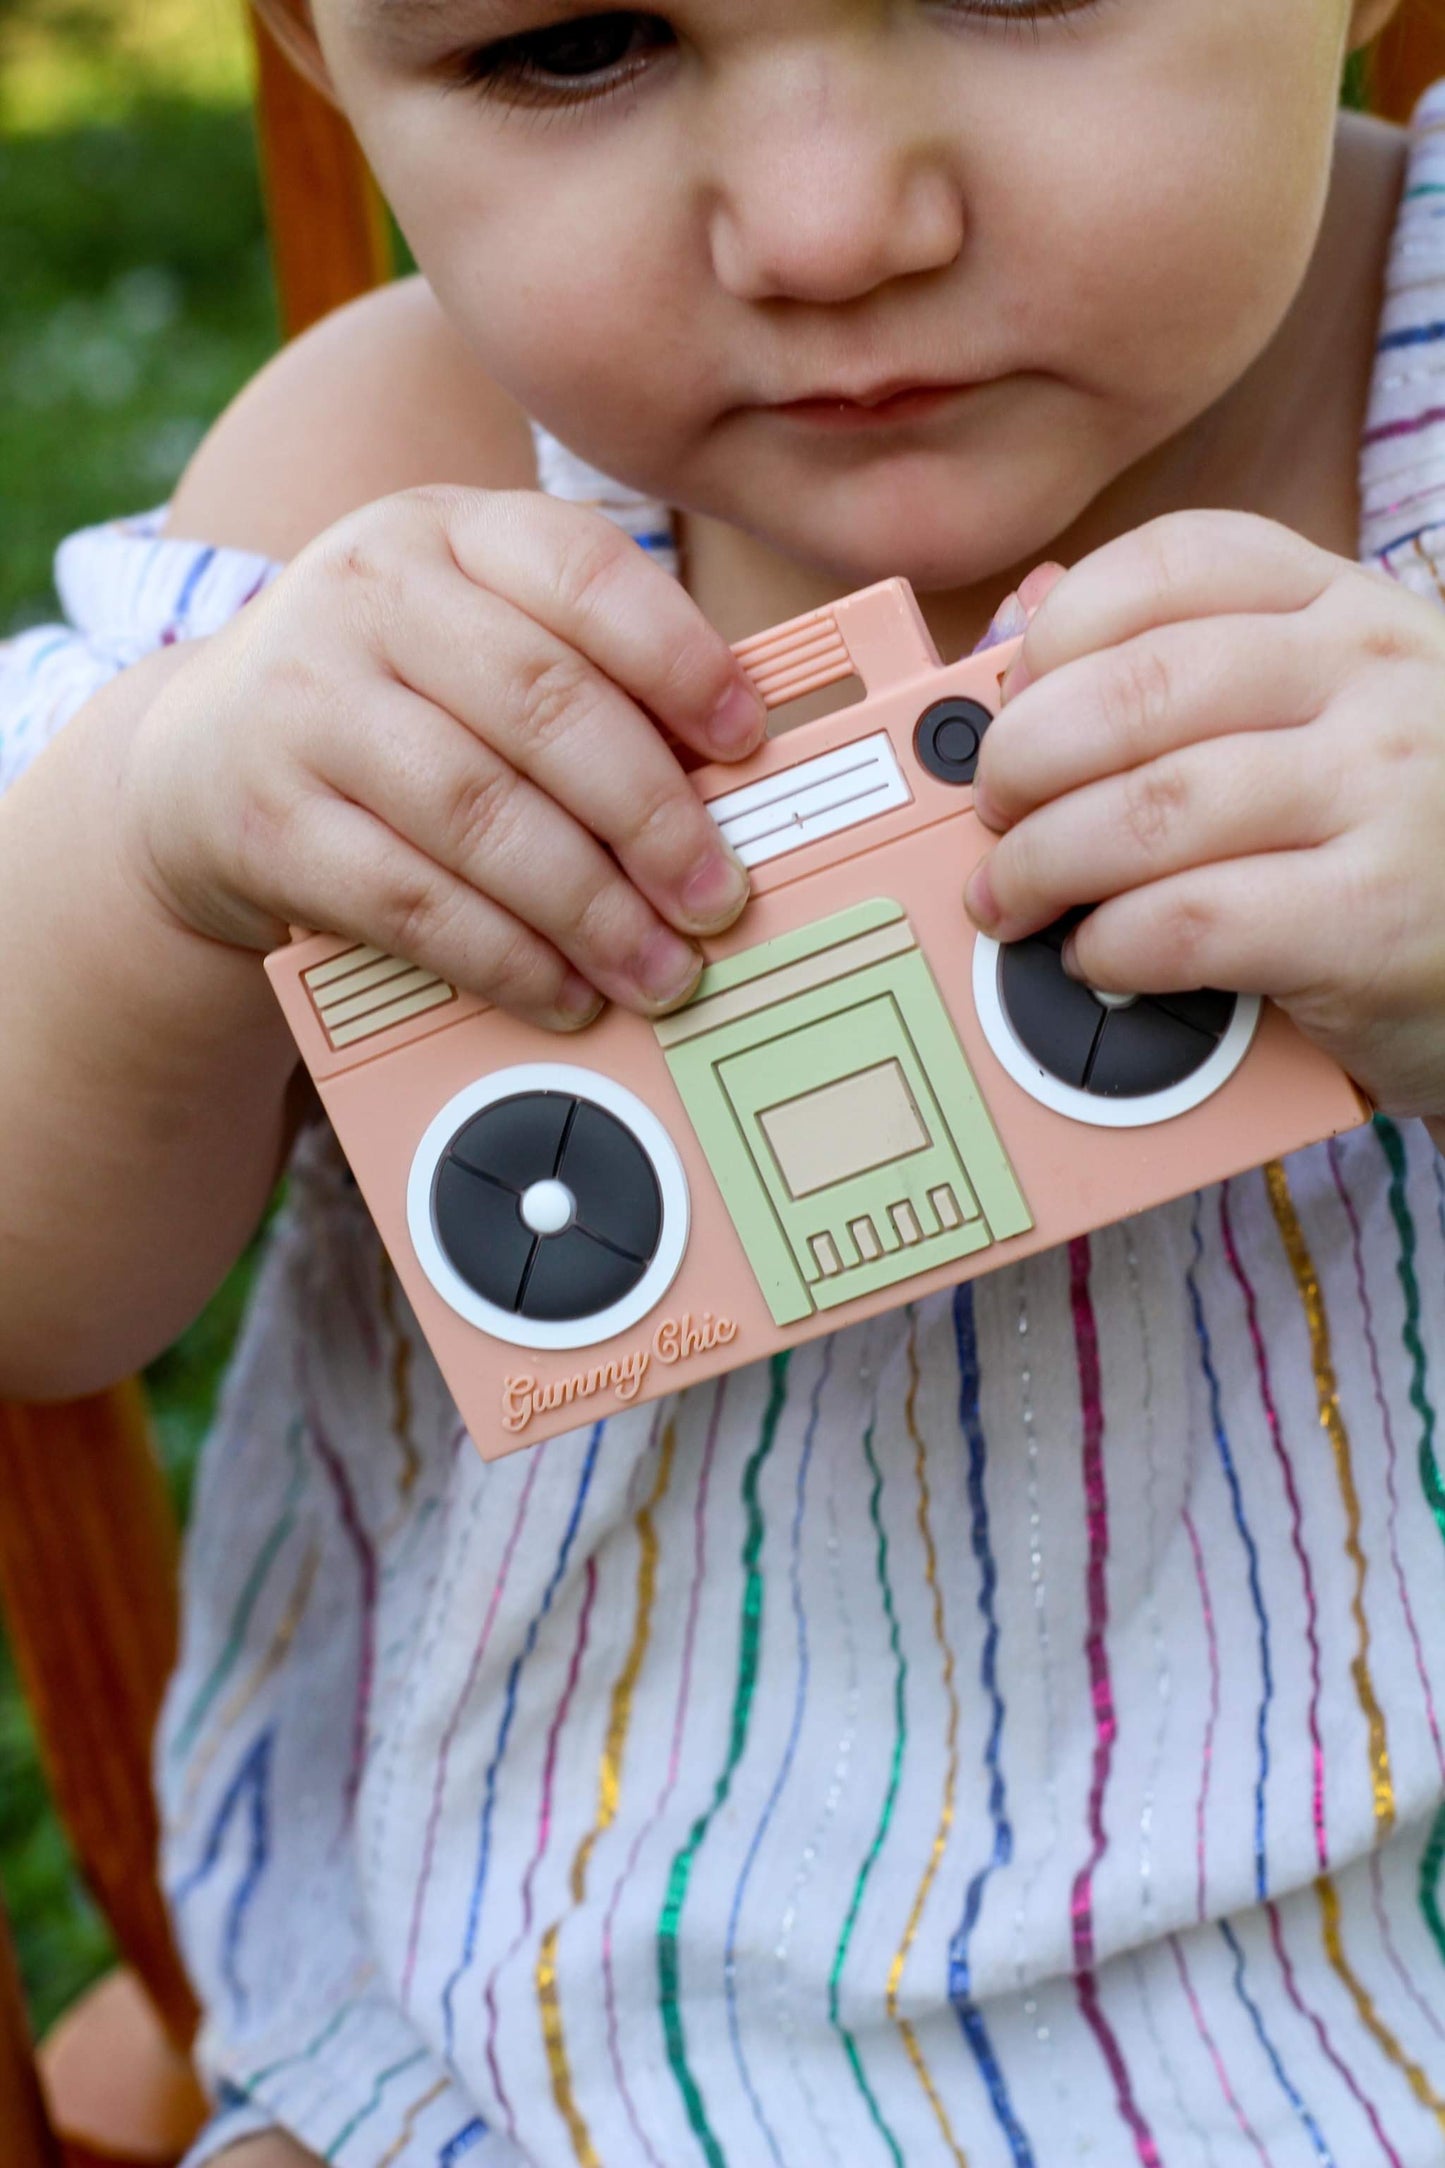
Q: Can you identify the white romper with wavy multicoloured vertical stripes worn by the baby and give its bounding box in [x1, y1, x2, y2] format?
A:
[0, 87, 1445, 2168]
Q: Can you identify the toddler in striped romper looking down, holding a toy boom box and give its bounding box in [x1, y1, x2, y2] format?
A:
[0, 0, 1445, 2168]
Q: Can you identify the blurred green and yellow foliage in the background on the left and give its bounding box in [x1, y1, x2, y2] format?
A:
[0, 0, 277, 2029]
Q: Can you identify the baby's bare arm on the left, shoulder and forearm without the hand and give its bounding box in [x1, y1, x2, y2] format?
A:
[0, 280, 511, 1396]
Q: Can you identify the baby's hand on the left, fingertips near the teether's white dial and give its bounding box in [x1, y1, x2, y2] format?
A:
[121, 488, 765, 1030]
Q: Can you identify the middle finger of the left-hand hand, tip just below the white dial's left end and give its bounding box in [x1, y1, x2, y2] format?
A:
[340, 562, 747, 932]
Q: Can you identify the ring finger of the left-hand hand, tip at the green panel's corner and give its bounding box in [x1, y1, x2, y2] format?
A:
[321, 683, 702, 1012]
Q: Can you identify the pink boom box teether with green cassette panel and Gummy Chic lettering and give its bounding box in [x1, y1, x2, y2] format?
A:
[266, 579, 1369, 1459]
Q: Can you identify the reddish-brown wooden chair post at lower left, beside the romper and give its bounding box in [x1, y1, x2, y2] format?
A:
[0, 1381, 197, 2046]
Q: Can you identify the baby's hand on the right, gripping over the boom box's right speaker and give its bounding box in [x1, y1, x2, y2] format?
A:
[966, 512, 1445, 1119]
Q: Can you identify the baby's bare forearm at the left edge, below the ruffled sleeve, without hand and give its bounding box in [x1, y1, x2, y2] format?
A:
[0, 648, 305, 1398]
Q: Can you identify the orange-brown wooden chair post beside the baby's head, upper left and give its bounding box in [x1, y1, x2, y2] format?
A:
[247, 9, 392, 338]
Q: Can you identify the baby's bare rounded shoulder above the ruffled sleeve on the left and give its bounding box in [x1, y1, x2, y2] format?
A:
[165, 278, 537, 557]
